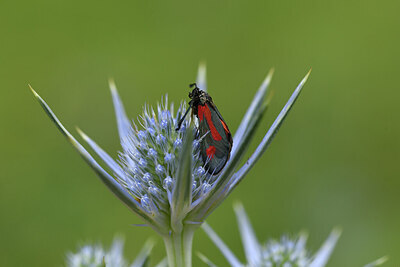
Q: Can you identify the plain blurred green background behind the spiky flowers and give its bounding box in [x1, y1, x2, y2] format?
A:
[0, 0, 400, 266]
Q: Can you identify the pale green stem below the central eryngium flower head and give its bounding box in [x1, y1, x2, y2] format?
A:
[164, 226, 195, 267]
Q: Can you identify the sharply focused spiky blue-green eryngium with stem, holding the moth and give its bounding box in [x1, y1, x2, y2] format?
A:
[31, 66, 309, 267]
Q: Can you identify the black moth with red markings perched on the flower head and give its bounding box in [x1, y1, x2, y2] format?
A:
[176, 83, 233, 175]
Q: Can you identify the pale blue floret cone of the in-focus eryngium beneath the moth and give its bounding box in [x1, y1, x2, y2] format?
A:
[116, 97, 212, 216]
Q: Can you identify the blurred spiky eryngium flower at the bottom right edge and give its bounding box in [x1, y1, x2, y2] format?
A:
[199, 203, 387, 267]
